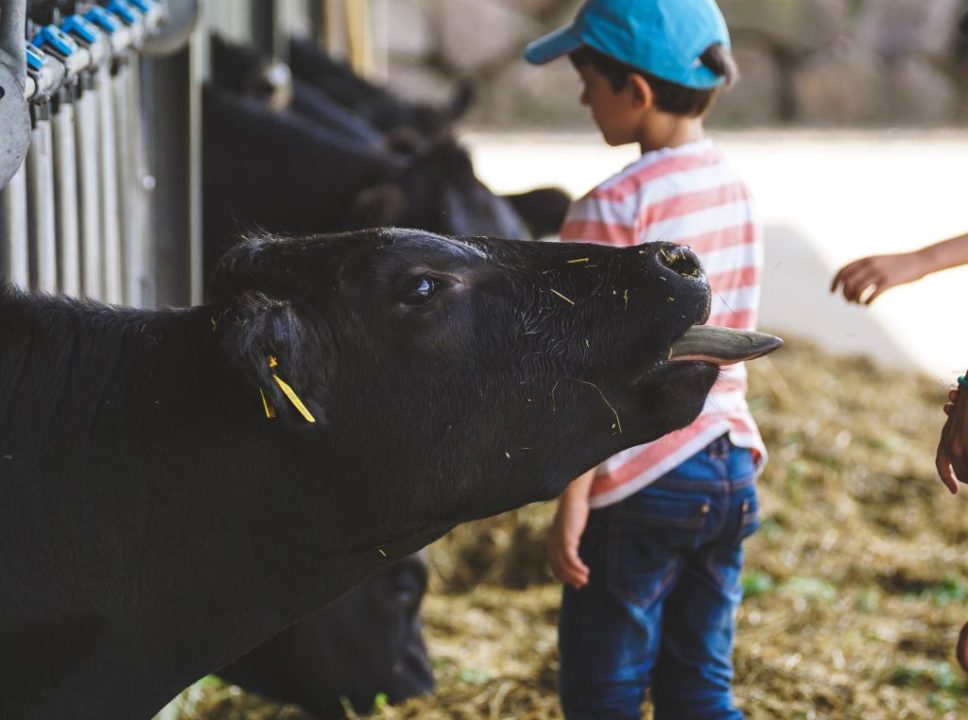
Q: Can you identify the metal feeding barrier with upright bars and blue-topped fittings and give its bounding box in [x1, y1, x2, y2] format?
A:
[0, 0, 195, 306]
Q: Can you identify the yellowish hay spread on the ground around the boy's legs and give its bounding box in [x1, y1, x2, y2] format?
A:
[163, 341, 968, 720]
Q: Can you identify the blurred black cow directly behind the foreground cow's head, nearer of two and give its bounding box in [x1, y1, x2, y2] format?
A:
[203, 87, 528, 274]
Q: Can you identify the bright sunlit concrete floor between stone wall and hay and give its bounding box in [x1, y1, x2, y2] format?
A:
[464, 131, 968, 384]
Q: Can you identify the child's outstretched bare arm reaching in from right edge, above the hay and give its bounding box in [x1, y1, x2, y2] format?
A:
[830, 234, 968, 305]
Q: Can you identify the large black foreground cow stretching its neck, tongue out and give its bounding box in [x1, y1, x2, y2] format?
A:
[0, 230, 775, 720]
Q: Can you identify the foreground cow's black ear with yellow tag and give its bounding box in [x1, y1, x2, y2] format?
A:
[216, 292, 333, 425]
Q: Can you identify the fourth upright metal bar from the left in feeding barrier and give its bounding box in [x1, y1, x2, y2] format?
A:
[74, 73, 104, 299]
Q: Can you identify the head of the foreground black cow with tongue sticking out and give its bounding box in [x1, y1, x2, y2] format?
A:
[217, 229, 778, 535]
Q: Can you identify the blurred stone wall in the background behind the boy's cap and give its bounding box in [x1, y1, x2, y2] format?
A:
[376, 0, 968, 128]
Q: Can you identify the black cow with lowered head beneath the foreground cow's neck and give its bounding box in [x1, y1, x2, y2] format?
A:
[218, 555, 434, 720]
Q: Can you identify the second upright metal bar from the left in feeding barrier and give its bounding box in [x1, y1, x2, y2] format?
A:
[26, 103, 57, 293]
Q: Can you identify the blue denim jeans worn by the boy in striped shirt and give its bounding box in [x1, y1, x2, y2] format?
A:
[558, 436, 759, 720]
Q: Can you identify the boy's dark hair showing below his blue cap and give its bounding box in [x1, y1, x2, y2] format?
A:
[568, 43, 739, 117]
